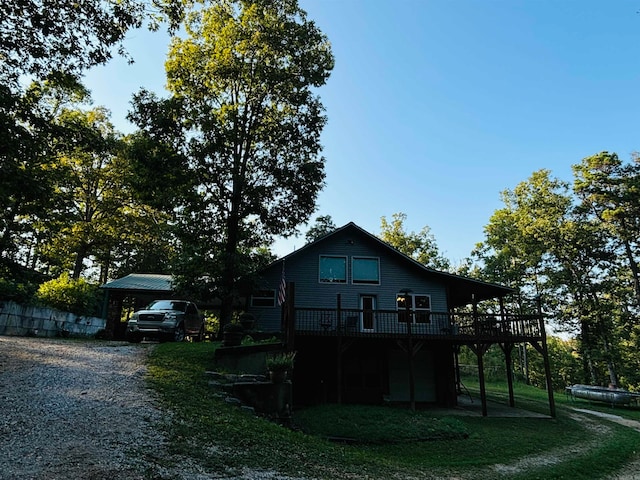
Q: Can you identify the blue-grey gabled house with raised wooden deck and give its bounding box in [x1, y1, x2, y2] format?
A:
[247, 223, 555, 415]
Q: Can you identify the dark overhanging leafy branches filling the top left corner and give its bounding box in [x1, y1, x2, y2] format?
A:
[0, 0, 192, 93]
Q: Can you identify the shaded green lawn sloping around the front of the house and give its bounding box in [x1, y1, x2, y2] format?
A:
[149, 342, 640, 480]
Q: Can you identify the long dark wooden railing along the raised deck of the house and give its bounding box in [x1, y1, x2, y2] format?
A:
[295, 308, 544, 342]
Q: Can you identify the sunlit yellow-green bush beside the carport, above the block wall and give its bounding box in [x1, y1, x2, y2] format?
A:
[36, 273, 101, 315]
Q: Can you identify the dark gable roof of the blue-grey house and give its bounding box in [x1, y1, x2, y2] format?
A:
[271, 222, 515, 307]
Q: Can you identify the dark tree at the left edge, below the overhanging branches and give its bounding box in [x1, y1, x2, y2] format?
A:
[0, 77, 87, 274]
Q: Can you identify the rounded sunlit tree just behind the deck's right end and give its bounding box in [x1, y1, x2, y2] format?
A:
[476, 170, 618, 384]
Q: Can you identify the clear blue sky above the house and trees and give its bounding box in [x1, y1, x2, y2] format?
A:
[86, 0, 640, 264]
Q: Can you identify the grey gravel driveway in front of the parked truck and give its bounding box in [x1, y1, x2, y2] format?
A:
[0, 337, 165, 480]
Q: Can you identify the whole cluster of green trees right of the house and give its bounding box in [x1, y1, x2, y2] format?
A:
[474, 161, 640, 385]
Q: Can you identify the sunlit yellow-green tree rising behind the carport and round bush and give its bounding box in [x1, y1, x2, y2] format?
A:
[47, 102, 179, 282]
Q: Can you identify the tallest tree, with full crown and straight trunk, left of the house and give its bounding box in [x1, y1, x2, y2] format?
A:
[133, 0, 333, 324]
